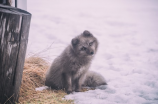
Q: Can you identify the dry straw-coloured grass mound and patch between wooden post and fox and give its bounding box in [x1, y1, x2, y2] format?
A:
[19, 57, 73, 104]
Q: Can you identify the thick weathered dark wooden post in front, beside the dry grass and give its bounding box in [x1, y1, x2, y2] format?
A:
[0, 5, 31, 104]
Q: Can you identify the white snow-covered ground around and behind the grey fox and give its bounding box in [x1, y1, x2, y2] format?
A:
[27, 0, 158, 104]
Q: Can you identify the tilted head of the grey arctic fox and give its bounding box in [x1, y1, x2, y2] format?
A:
[71, 30, 98, 57]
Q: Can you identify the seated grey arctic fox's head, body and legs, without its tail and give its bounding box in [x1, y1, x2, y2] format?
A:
[45, 30, 106, 94]
